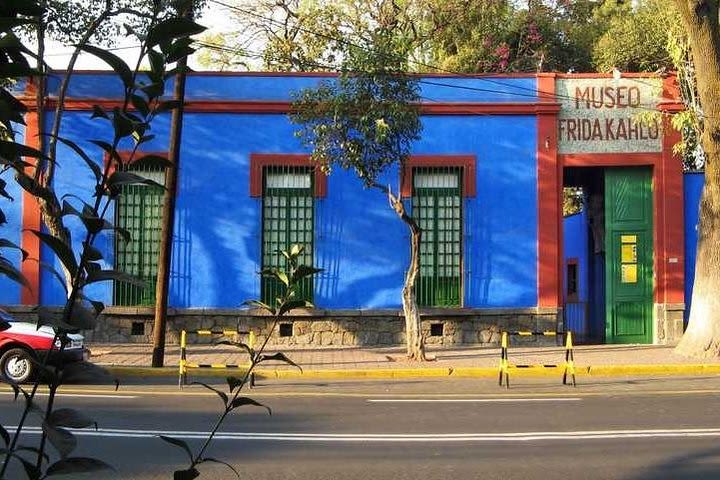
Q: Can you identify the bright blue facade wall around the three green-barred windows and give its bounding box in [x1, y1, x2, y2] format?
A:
[2, 75, 538, 308]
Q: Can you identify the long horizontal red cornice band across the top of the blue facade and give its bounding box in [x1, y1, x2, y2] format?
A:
[36, 98, 560, 115]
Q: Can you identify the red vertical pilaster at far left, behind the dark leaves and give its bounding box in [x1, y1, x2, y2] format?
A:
[20, 112, 42, 305]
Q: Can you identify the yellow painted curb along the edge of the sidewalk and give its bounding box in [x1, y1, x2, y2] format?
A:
[104, 364, 720, 380]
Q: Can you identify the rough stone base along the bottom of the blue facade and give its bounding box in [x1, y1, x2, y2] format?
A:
[1, 307, 562, 348]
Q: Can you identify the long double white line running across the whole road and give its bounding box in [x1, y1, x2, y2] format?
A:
[7, 426, 720, 443]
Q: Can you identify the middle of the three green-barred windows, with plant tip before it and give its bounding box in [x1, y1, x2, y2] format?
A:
[260, 166, 315, 304]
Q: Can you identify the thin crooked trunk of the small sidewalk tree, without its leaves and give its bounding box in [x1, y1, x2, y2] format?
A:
[388, 189, 427, 362]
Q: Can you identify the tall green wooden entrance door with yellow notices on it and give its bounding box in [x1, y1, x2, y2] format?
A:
[605, 167, 653, 343]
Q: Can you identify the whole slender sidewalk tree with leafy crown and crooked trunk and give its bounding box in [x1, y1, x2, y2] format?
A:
[291, 22, 425, 361]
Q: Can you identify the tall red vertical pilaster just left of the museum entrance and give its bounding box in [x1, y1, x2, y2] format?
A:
[537, 75, 563, 307]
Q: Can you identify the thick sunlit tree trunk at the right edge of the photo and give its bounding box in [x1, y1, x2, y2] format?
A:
[675, 0, 720, 358]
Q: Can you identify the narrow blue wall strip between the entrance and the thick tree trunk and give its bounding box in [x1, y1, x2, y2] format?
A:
[683, 172, 705, 325]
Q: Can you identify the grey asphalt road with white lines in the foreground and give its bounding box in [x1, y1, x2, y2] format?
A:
[0, 377, 720, 480]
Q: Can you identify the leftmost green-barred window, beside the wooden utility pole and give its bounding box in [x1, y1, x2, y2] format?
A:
[114, 164, 165, 306]
